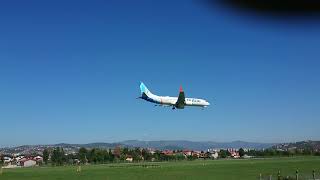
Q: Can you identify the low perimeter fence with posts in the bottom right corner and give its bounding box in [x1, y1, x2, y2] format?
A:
[258, 170, 320, 180]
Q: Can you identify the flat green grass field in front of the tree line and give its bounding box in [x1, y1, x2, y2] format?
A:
[0, 157, 320, 180]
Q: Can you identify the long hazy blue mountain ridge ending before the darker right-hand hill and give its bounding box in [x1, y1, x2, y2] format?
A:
[0, 140, 275, 154]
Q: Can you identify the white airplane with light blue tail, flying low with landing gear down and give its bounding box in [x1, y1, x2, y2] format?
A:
[138, 82, 210, 109]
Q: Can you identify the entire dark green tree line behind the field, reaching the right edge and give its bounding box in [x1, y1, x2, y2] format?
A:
[39, 147, 320, 166]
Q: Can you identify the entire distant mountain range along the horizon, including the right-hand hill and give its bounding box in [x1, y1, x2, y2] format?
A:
[0, 140, 320, 154]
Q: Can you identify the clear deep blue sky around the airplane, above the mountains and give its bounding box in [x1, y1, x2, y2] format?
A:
[0, 0, 320, 147]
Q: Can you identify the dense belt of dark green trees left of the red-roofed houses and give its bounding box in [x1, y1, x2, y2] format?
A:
[43, 147, 195, 166]
